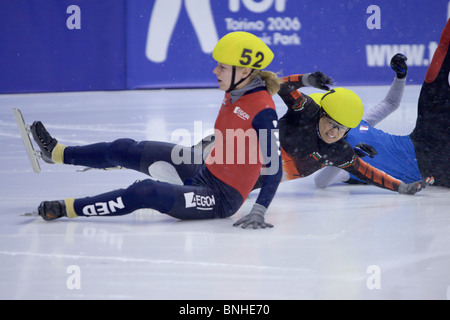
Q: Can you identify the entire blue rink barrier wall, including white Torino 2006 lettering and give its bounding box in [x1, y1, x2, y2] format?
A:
[0, 0, 450, 93]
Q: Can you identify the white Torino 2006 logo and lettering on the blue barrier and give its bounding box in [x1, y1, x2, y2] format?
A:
[145, 0, 290, 63]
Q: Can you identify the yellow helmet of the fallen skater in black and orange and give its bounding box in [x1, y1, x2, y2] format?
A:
[310, 88, 363, 128]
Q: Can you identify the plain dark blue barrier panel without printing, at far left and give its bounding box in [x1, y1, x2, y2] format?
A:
[0, 0, 126, 93]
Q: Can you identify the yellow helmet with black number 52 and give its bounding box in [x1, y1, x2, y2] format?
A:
[213, 31, 274, 70]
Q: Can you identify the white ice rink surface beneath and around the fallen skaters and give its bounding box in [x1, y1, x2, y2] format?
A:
[0, 86, 450, 300]
